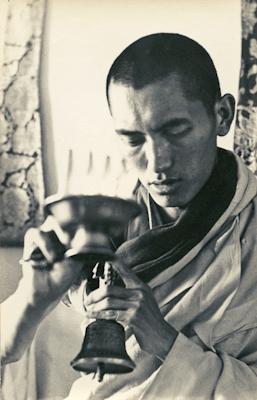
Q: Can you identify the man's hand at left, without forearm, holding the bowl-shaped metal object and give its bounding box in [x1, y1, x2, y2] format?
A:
[22, 218, 83, 308]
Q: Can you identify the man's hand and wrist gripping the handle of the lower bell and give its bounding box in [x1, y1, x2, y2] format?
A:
[85, 261, 177, 360]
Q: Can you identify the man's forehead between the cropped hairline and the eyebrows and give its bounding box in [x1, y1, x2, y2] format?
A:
[109, 74, 200, 130]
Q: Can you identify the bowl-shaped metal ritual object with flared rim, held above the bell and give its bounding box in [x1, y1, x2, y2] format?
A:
[45, 195, 141, 262]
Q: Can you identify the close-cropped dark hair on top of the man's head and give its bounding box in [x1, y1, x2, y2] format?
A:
[106, 33, 221, 112]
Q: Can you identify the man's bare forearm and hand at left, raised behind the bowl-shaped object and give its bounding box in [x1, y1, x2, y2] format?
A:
[1, 222, 82, 364]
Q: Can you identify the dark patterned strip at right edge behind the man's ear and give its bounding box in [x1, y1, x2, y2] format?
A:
[234, 0, 257, 175]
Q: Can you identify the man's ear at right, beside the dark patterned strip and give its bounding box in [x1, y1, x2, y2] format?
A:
[215, 93, 235, 136]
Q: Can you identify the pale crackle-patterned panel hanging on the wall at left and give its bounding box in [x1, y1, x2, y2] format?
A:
[0, 0, 44, 245]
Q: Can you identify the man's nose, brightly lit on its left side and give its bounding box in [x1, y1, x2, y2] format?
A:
[146, 137, 173, 173]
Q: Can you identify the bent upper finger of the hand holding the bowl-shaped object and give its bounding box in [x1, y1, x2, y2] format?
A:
[23, 228, 66, 264]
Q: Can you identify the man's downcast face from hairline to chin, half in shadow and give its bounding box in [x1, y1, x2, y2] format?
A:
[109, 74, 217, 207]
